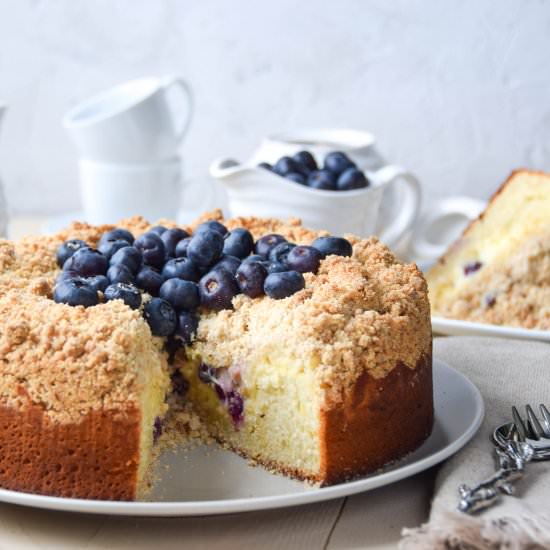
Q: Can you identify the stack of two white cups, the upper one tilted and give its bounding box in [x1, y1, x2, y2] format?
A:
[63, 76, 192, 224]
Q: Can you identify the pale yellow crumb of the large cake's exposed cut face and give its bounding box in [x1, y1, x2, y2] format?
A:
[178, 350, 321, 479]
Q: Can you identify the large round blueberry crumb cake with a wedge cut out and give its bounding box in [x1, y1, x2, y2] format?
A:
[0, 212, 433, 500]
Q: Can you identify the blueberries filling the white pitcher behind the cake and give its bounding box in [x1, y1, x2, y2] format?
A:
[258, 151, 369, 191]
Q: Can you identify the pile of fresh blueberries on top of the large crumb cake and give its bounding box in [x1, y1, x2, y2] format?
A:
[53, 220, 352, 343]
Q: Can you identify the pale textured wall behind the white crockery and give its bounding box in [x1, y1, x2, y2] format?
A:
[0, 0, 550, 213]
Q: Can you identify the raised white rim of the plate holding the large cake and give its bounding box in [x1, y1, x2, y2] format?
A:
[0, 358, 485, 517]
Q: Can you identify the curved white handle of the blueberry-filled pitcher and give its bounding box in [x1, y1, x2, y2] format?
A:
[376, 164, 422, 246]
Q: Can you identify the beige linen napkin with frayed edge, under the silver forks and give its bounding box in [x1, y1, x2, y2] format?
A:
[400, 337, 550, 550]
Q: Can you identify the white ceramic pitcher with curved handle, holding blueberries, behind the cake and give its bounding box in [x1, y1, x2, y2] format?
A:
[210, 128, 421, 246]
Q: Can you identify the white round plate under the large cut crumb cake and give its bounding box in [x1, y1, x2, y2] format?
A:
[0, 360, 483, 516]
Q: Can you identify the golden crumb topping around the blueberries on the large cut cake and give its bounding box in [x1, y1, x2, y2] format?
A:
[0, 211, 431, 421]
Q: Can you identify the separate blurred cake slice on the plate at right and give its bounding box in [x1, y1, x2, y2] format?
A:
[427, 170, 550, 330]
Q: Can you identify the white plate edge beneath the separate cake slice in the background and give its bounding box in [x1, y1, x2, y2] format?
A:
[432, 317, 550, 342]
